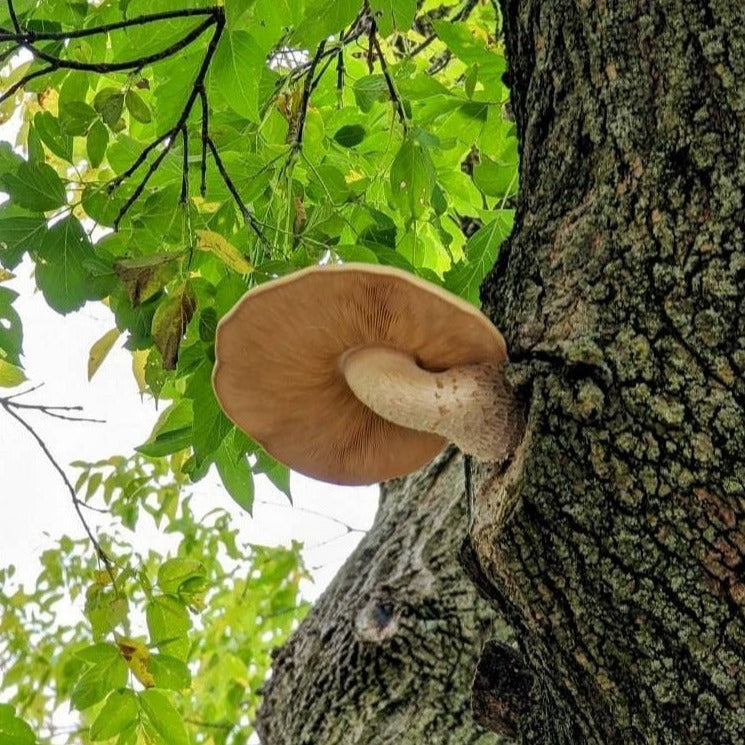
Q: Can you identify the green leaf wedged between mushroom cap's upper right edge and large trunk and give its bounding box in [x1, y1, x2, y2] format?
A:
[445, 210, 513, 306]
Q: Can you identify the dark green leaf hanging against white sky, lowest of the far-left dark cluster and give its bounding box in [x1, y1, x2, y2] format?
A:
[36, 216, 94, 314]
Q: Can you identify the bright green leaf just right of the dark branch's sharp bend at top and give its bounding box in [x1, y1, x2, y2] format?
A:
[210, 31, 266, 122]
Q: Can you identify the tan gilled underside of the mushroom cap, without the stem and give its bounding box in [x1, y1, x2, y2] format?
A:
[213, 264, 507, 484]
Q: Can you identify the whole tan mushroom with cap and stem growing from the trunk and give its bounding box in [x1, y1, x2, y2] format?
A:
[213, 264, 524, 484]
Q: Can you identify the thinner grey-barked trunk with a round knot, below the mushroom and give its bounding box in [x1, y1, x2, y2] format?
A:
[257, 449, 506, 745]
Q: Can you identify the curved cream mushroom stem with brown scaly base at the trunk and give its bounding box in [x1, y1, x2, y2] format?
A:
[339, 346, 525, 461]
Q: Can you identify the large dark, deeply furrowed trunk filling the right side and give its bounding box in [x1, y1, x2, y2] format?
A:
[465, 0, 745, 745]
